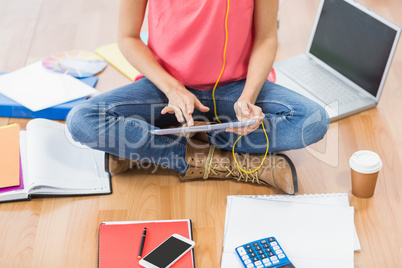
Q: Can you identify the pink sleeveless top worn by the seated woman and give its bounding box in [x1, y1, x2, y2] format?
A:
[148, 0, 254, 90]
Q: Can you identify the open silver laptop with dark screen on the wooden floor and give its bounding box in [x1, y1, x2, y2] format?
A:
[274, 0, 401, 121]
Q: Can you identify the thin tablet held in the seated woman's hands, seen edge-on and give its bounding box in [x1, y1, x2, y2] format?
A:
[151, 120, 255, 135]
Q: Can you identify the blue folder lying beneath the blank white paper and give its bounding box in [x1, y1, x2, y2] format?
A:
[0, 72, 98, 120]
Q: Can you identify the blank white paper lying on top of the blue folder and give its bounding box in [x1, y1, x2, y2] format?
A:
[0, 61, 98, 112]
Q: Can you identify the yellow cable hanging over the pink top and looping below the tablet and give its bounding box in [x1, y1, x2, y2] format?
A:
[212, 0, 269, 173]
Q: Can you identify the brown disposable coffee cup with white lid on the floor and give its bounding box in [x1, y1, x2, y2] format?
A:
[349, 150, 382, 198]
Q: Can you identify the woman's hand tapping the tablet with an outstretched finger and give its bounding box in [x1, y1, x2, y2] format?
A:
[161, 85, 209, 127]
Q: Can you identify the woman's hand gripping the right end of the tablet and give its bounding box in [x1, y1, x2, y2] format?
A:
[226, 99, 265, 135]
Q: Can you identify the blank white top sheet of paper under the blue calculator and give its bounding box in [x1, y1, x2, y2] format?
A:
[221, 196, 354, 268]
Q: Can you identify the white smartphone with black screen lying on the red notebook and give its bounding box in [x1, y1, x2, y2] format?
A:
[139, 234, 195, 268]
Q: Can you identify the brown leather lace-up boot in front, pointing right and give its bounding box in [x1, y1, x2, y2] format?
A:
[180, 138, 298, 194]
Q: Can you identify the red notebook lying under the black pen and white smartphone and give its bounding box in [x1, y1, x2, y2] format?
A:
[98, 219, 195, 268]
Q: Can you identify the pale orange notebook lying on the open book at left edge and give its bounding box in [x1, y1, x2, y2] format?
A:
[0, 124, 20, 188]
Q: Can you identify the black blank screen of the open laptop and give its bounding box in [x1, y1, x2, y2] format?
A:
[310, 0, 397, 97]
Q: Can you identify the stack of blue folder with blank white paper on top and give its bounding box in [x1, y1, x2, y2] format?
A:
[0, 62, 98, 120]
